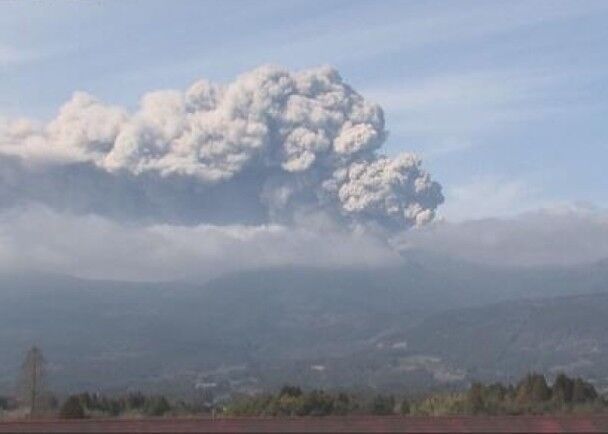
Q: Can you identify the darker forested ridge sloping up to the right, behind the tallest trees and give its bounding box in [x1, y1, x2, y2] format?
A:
[404, 293, 608, 385]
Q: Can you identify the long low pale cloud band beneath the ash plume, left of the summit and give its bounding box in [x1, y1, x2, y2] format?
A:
[0, 206, 399, 280]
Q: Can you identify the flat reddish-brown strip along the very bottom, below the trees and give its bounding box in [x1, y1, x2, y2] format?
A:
[0, 416, 608, 434]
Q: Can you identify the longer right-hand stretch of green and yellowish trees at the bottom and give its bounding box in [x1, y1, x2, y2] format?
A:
[224, 374, 608, 416]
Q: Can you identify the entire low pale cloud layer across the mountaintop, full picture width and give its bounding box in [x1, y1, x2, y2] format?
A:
[0, 202, 608, 280]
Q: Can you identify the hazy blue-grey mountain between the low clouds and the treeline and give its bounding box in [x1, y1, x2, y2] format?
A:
[0, 253, 608, 394]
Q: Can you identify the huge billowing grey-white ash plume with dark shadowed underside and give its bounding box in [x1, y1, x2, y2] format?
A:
[0, 67, 443, 228]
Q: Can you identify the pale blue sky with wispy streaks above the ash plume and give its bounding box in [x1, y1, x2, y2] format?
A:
[0, 0, 608, 220]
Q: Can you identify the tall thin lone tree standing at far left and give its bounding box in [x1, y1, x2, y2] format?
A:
[18, 346, 48, 416]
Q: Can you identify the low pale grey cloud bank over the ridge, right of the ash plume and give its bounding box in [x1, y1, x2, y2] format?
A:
[400, 206, 608, 266]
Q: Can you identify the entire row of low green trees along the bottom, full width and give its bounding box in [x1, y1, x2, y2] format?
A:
[0, 374, 608, 419]
